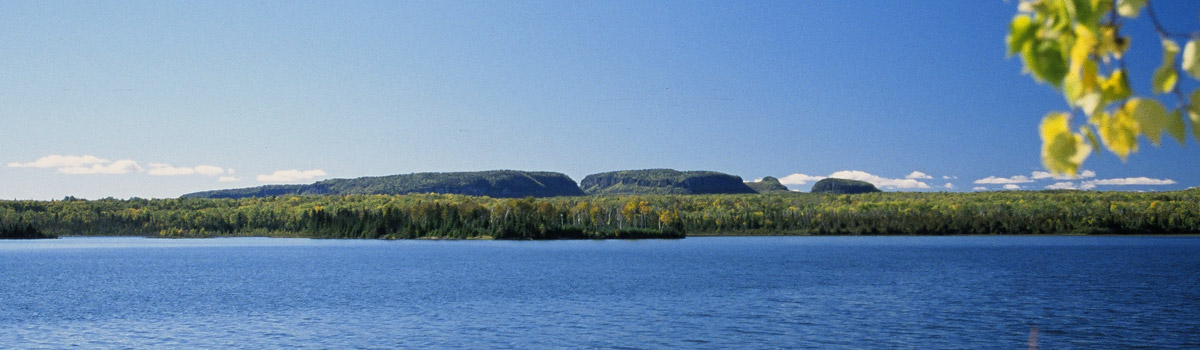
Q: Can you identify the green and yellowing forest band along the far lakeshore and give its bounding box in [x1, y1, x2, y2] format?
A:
[0, 189, 1200, 240]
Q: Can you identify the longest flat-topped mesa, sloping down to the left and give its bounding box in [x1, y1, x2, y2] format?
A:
[182, 170, 583, 198]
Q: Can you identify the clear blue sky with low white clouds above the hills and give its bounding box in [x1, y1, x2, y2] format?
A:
[0, 0, 1200, 199]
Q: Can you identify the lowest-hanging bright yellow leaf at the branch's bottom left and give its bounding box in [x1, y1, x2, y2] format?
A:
[1039, 113, 1092, 175]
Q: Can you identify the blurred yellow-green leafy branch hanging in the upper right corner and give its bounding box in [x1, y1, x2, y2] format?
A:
[1006, 0, 1200, 175]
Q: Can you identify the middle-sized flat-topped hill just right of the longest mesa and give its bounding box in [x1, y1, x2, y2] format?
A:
[580, 169, 755, 194]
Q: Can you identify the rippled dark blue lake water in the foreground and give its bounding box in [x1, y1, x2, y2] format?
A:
[0, 236, 1200, 349]
